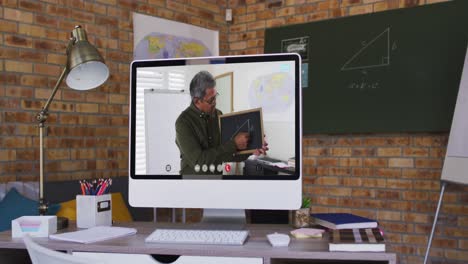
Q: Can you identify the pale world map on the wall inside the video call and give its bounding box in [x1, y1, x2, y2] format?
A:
[249, 72, 294, 113]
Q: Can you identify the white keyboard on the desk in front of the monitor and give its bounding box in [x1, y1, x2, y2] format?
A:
[145, 229, 249, 245]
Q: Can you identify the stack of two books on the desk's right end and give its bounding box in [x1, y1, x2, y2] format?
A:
[311, 213, 385, 252]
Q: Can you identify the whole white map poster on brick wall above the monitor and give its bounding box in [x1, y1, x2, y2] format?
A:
[133, 13, 219, 60]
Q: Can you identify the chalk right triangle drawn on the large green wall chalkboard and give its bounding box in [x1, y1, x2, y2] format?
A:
[341, 28, 390, 71]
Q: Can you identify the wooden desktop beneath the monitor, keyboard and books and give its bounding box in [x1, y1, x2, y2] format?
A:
[0, 222, 396, 264]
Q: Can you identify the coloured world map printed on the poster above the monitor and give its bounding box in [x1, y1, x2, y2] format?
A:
[133, 32, 211, 60]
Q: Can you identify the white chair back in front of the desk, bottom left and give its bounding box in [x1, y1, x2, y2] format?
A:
[23, 235, 104, 264]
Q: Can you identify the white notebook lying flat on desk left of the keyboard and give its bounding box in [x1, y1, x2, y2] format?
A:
[49, 226, 137, 244]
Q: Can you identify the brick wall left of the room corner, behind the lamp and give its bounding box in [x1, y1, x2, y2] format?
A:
[0, 0, 227, 182]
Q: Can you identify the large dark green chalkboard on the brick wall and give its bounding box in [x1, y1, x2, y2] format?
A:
[265, 0, 468, 134]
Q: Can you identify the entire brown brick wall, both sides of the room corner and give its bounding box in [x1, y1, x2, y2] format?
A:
[0, 0, 468, 263]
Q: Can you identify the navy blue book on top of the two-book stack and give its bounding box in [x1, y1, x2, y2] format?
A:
[311, 213, 377, 229]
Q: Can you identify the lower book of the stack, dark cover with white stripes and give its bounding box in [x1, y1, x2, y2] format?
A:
[328, 228, 385, 252]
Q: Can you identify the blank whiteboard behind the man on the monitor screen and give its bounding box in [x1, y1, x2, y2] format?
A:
[144, 90, 190, 175]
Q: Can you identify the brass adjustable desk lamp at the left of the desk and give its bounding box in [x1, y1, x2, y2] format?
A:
[36, 26, 109, 215]
